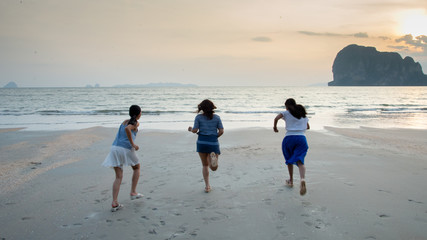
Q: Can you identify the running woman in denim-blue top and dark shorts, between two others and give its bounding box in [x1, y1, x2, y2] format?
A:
[188, 99, 224, 193]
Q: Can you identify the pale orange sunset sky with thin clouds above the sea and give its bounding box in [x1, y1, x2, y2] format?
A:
[0, 0, 427, 87]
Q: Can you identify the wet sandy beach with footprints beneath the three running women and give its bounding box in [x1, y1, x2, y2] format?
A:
[0, 127, 427, 240]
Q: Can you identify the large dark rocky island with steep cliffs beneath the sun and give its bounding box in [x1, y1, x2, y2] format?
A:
[328, 44, 427, 86]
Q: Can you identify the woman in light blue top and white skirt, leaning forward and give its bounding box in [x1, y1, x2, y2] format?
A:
[102, 105, 143, 212]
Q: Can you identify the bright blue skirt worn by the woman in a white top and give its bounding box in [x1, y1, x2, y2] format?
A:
[282, 135, 308, 165]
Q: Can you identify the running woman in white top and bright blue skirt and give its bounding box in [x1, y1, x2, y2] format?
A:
[273, 98, 310, 195]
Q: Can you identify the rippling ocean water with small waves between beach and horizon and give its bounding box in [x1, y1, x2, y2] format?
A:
[0, 87, 427, 131]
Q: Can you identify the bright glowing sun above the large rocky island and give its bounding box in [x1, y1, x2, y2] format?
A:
[399, 9, 427, 37]
